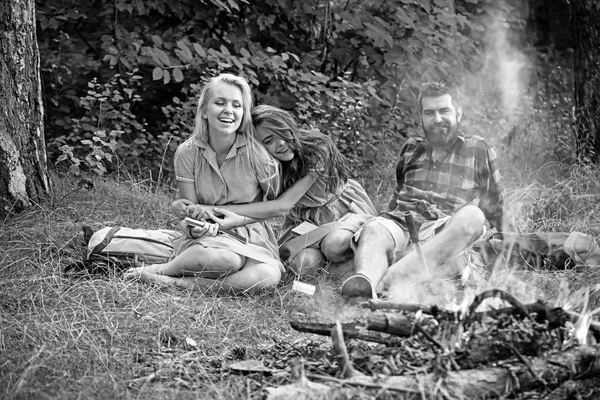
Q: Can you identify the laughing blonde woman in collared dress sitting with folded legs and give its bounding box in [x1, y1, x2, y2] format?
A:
[124, 74, 284, 291]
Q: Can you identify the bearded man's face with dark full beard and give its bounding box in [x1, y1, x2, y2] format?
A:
[421, 94, 462, 147]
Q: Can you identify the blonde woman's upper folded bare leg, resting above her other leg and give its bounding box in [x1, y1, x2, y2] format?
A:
[125, 244, 246, 279]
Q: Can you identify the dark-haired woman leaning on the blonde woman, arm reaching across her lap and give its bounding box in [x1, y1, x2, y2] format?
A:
[188, 105, 376, 276]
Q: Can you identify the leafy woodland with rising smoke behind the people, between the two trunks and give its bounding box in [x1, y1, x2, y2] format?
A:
[37, 0, 576, 196]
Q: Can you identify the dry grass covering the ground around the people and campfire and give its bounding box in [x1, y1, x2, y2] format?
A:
[0, 90, 600, 399]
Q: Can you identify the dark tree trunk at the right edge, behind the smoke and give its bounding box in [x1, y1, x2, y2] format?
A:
[571, 0, 600, 163]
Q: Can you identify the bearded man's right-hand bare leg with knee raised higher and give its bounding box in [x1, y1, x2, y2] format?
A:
[383, 206, 485, 297]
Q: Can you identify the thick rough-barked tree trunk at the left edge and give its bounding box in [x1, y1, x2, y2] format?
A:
[0, 0, 50, 216]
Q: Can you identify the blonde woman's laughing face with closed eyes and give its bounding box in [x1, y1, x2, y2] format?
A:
[203, 82, 244, 135]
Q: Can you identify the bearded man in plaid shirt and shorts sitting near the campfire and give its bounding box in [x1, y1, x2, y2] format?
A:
[342, 82, 502, 300]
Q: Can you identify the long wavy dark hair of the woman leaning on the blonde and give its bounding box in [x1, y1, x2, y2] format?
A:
[252, 105, 349, 192]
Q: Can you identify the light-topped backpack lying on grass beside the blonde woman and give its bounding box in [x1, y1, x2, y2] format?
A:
[64, 226, 182, 275]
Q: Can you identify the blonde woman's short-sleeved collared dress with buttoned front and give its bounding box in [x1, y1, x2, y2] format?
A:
[174, 134, 284, 272]
